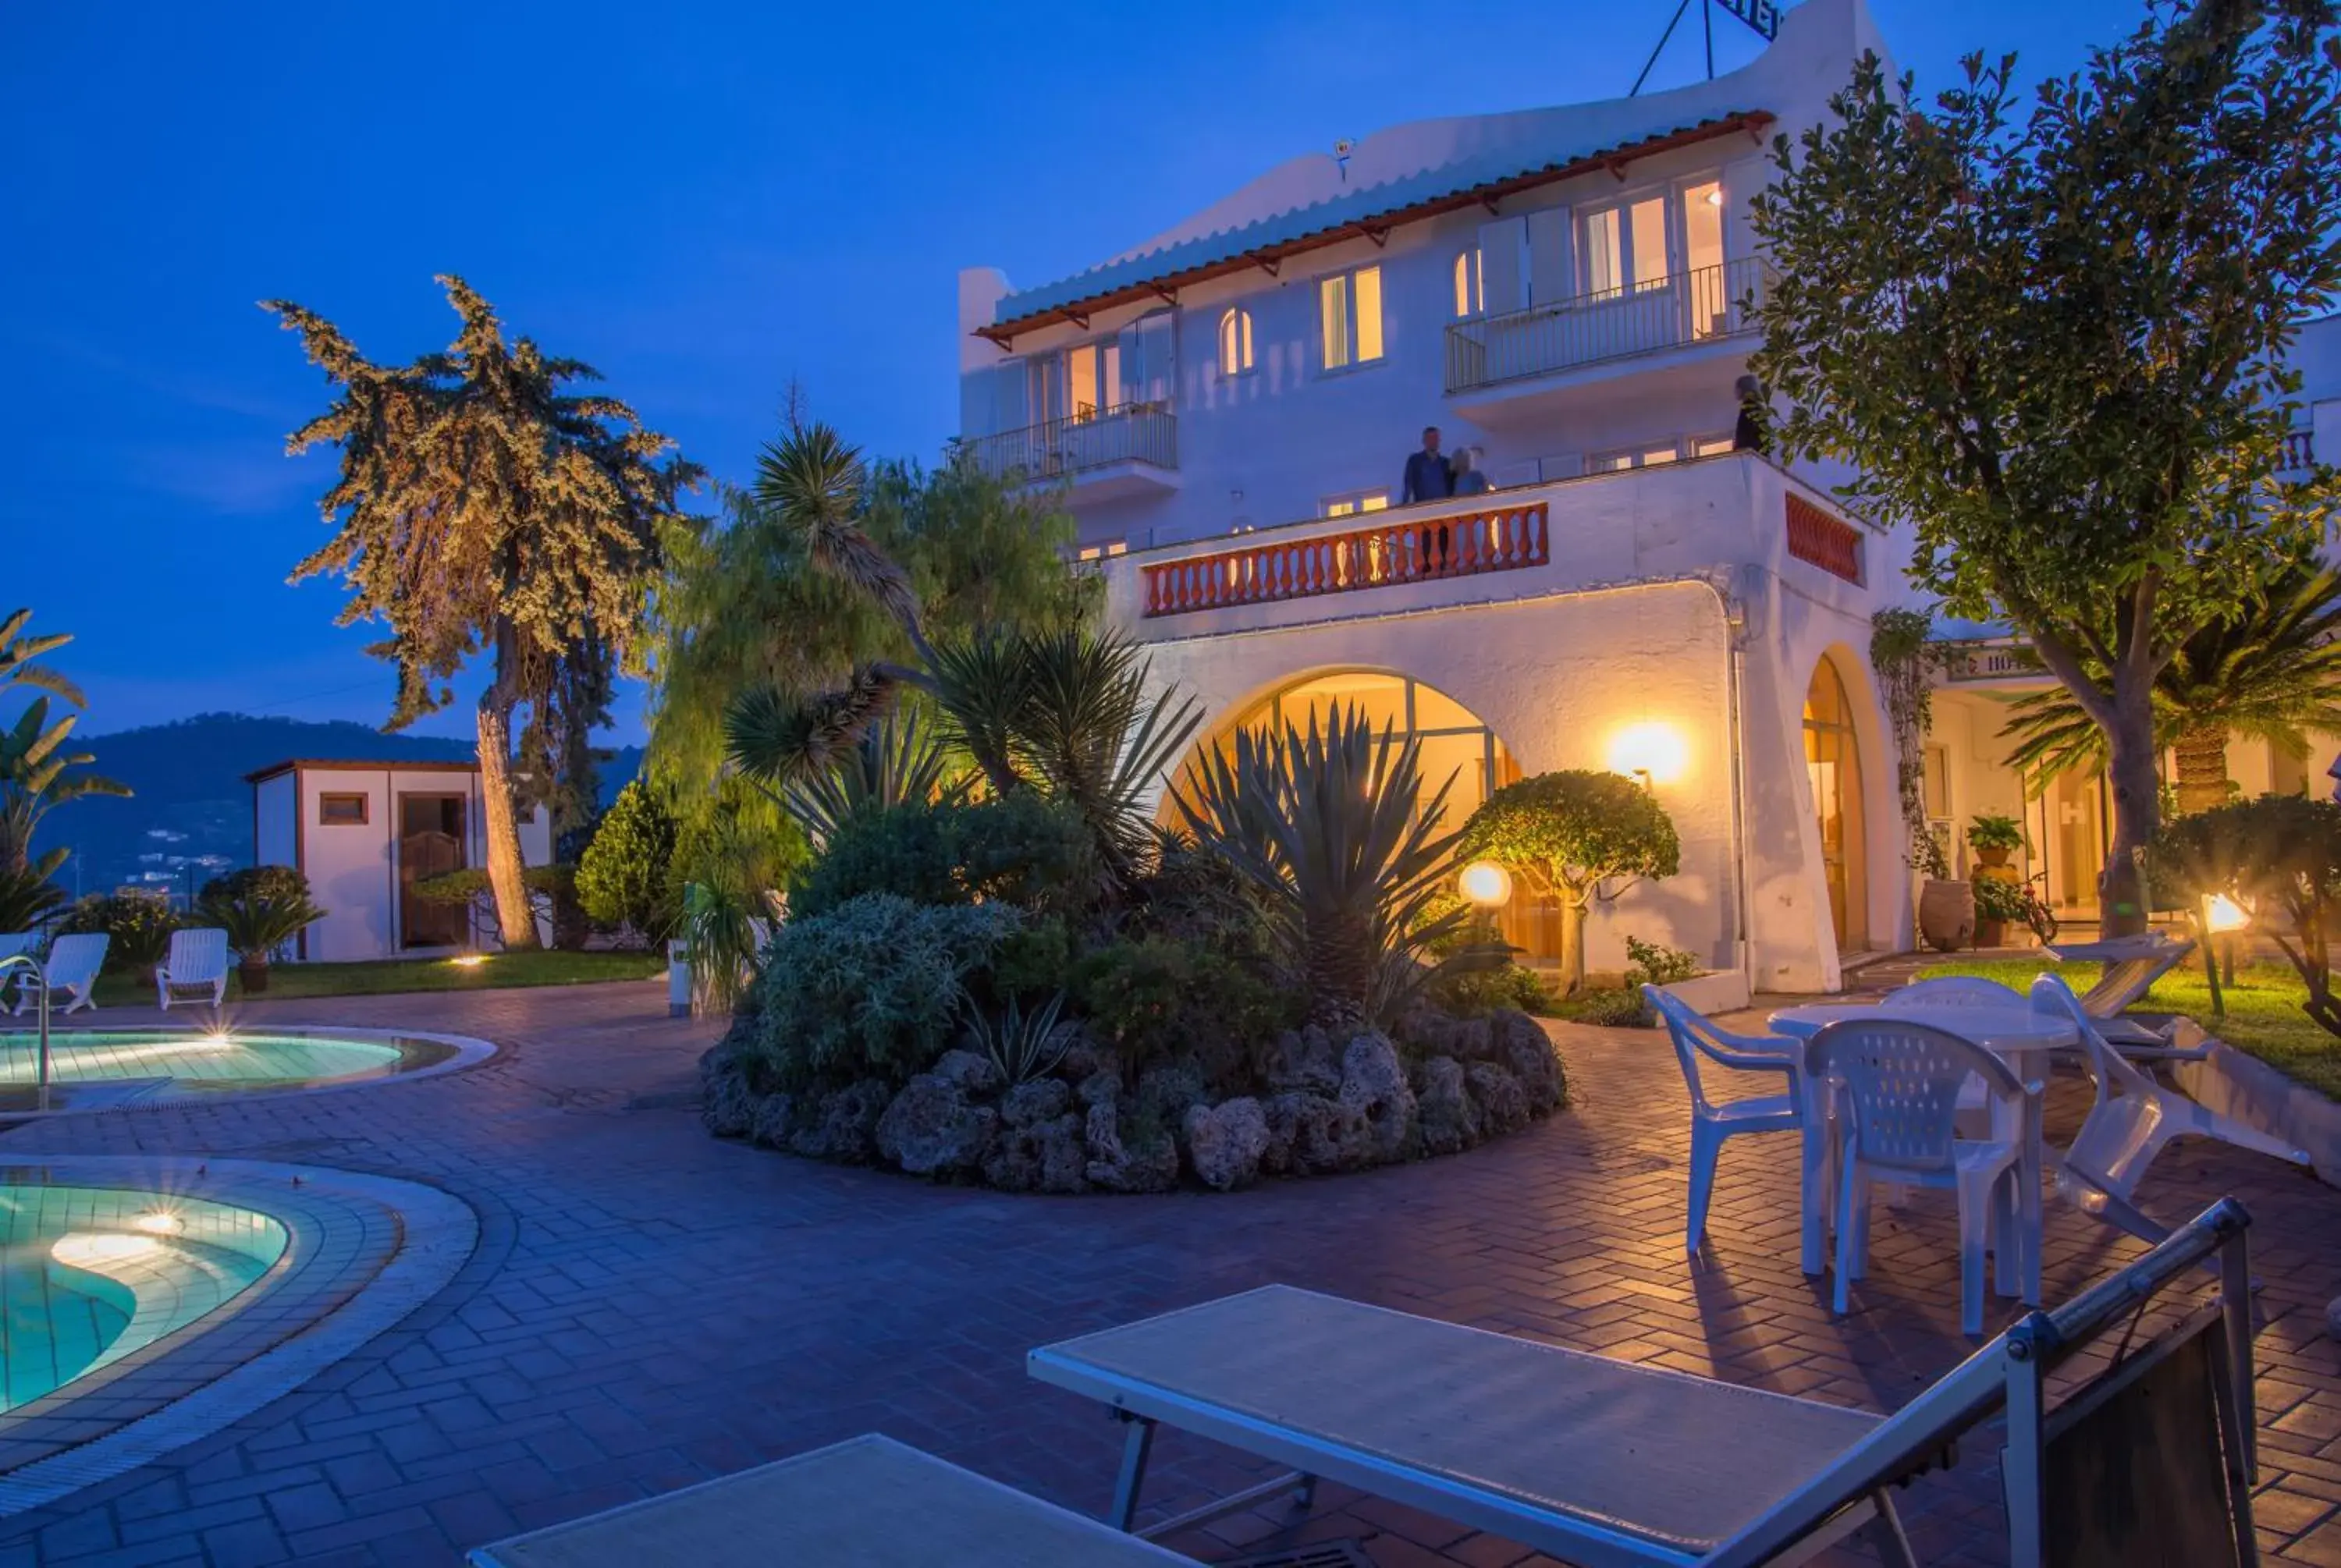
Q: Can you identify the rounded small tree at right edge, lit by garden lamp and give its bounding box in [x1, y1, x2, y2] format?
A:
[2154, 796, 2341, 1034]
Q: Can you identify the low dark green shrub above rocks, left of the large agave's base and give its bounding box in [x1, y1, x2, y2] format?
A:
[1067, 934, 1302, 1088]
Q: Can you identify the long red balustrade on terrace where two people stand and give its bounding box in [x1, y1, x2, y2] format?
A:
[1145, 501, 1552, 618]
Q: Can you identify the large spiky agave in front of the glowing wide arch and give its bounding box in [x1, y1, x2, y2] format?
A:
[1178, 707, 1480, 1030]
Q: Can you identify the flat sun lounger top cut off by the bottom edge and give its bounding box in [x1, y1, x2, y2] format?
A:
[468, 1435, 1194, 1568]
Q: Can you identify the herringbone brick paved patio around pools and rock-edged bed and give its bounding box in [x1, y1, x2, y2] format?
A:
[0, 983, 2341, 1568]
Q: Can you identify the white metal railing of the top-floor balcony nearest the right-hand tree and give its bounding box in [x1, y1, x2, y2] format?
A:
[1447, 255, 1765, 393]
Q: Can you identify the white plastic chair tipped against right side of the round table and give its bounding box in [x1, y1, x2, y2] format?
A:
[2032, 974, 2308, 1240]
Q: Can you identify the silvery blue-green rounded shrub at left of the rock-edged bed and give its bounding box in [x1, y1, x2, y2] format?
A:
[747, 894, 1025, 1091]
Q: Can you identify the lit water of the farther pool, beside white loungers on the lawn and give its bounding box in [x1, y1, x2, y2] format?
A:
[0, 1025, 485, 1114]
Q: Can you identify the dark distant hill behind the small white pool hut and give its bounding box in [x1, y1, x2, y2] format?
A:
[37, 714, 641, 892]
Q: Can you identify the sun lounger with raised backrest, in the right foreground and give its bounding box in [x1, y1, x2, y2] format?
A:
[1025, 1201, 2254, 1568]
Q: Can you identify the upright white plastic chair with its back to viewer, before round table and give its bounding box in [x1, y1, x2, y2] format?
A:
[1805, 1018, 2041, 1334]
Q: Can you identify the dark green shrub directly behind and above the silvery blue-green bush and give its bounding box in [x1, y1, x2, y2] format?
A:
[789, 789, 1098, 915]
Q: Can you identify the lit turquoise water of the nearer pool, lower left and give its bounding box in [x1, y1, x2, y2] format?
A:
[0, 1184, 288, 1411]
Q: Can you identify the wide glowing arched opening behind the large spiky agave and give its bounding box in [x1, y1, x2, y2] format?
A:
[1163, 669, 1559, 957]
